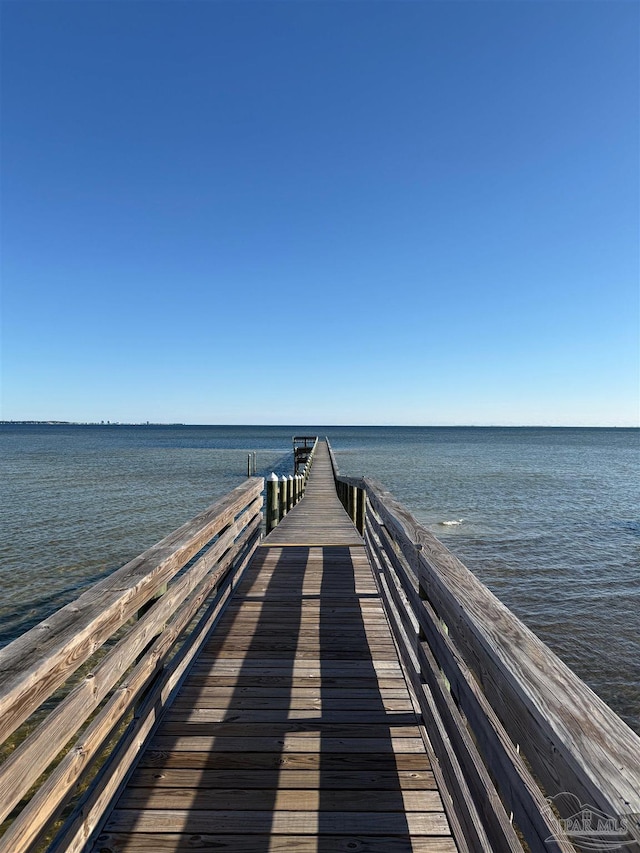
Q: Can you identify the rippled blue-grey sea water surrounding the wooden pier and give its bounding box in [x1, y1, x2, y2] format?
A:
[0, 425, 640, 732]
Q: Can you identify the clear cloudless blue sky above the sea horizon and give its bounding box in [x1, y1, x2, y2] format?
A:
[0, 0, 640, 425]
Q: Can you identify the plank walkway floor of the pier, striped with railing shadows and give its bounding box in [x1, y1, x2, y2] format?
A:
[93, 442, 457, 853]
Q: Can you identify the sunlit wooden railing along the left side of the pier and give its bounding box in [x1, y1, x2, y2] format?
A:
[0, 478, 264, 853]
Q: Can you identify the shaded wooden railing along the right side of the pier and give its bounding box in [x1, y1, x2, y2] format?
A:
[331, 440, 640, 853]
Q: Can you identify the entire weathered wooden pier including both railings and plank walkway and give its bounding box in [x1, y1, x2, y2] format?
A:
[0, 437, 640, 853]
